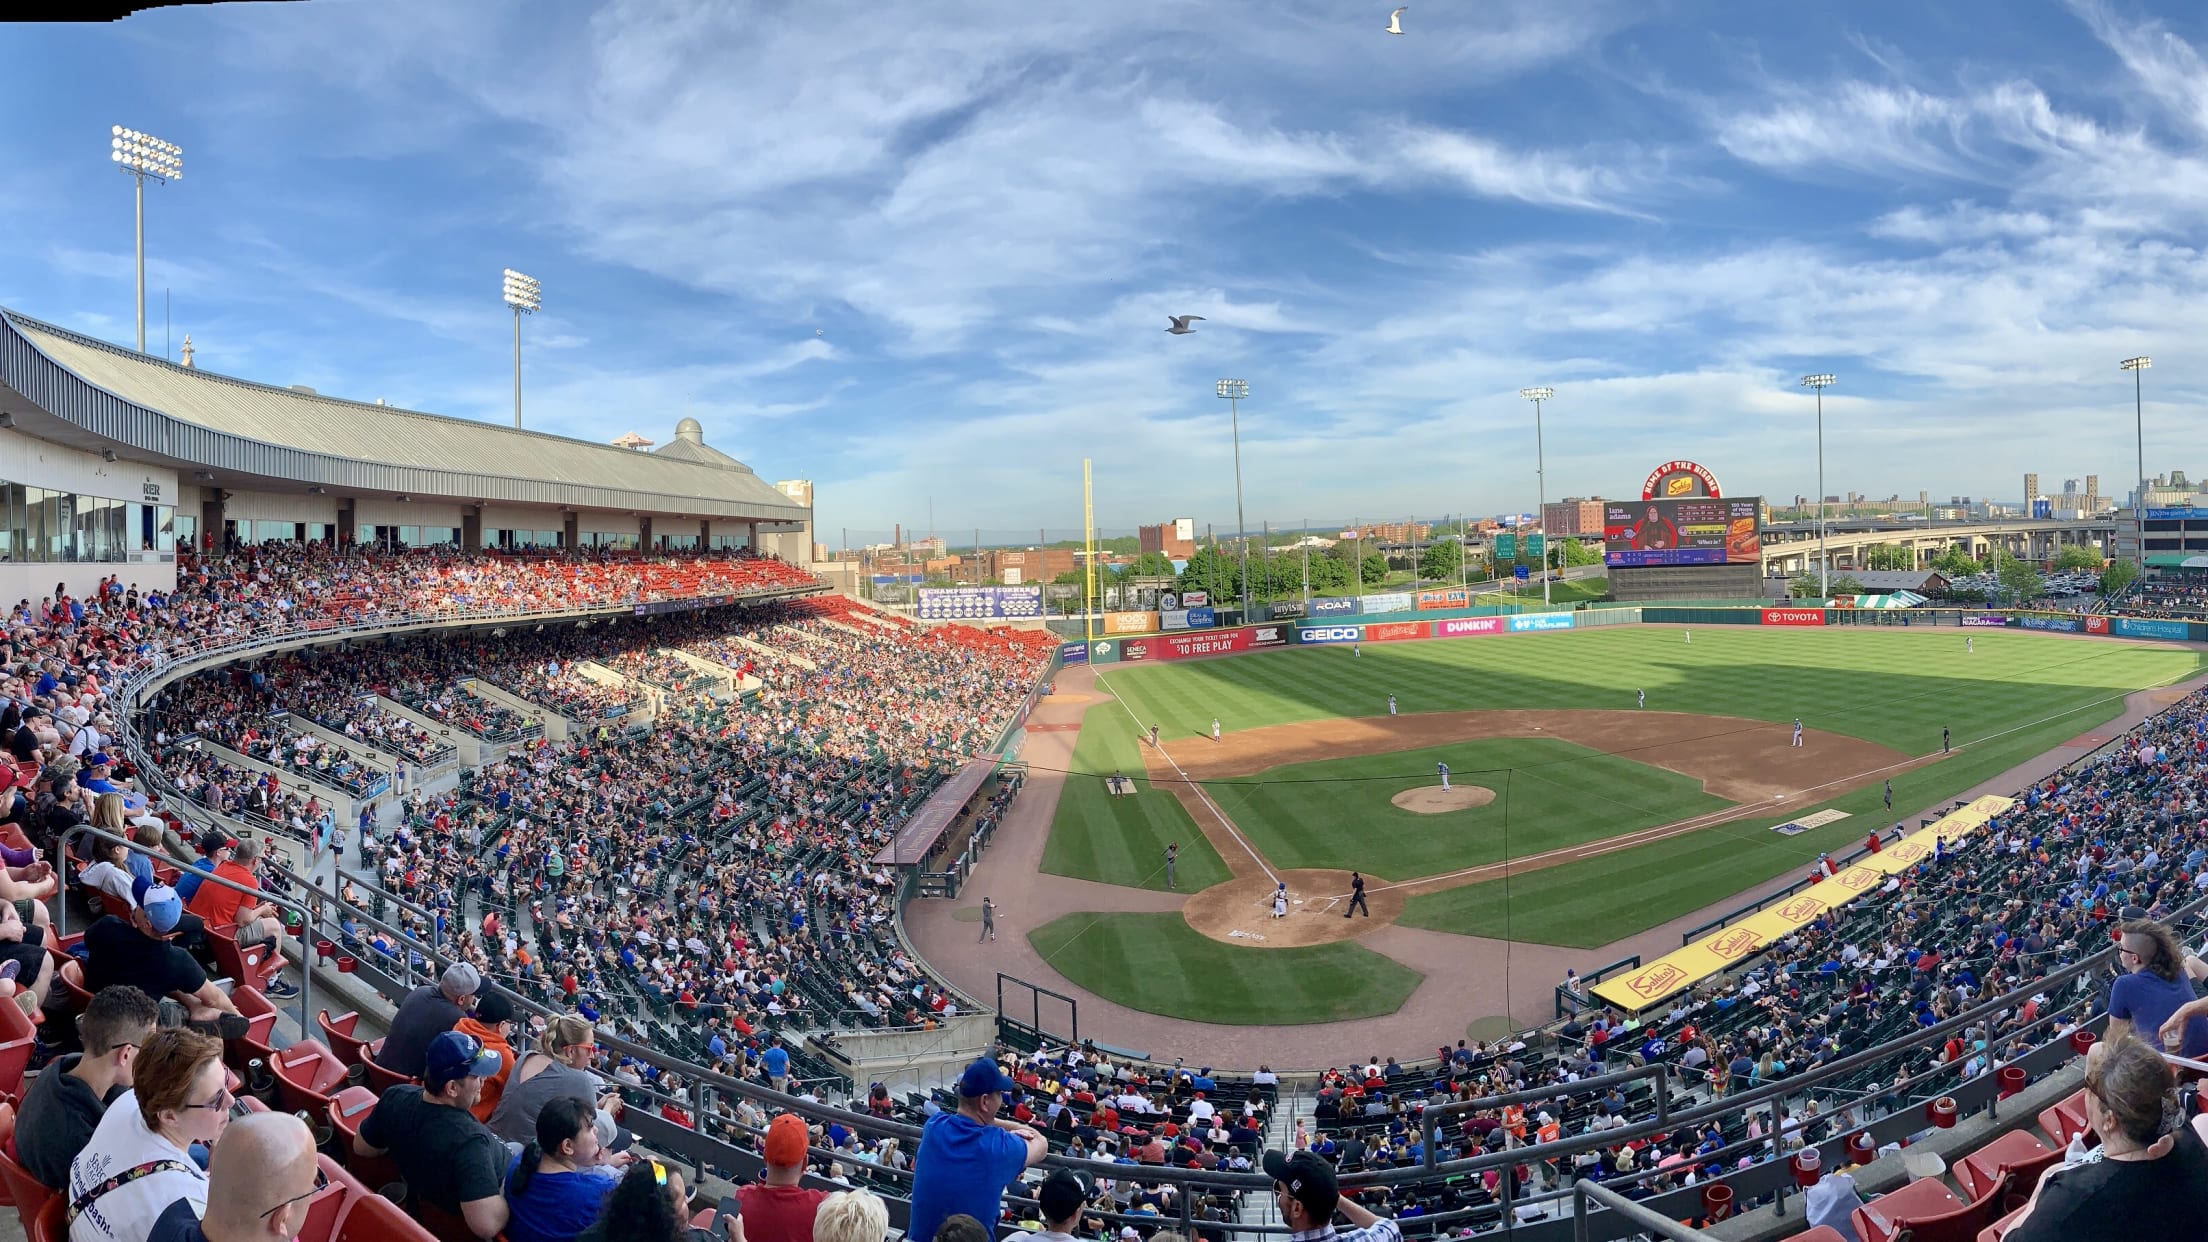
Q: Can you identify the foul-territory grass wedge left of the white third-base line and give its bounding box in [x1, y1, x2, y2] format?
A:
[1042, 703, 1232, 893]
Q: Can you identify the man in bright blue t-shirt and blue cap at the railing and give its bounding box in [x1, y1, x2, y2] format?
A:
[905, 1056, 1051, 1242]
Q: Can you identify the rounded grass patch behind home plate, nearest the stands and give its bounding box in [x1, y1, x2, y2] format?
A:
[1027, 913, 1424, 1025]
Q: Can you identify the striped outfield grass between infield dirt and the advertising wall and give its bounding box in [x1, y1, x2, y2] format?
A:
[1102, 625, 2201, 756]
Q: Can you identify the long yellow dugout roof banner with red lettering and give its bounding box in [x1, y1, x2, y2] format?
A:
[1594, 793, 2016, 1012]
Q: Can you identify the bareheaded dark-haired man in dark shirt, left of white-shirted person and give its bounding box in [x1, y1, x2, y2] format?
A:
[15, 986, 161, 1189]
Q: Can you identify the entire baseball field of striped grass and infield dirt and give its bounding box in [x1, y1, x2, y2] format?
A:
[1029, 625, 2204, 1025]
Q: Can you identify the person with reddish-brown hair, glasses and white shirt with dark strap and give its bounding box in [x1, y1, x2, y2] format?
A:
[64, 1028, 236, 1242]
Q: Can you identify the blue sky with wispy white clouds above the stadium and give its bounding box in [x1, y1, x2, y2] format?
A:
[0, 0, 2208, 544]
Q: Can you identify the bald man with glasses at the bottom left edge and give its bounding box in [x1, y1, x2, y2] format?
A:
[146, 1112, 325, 1242]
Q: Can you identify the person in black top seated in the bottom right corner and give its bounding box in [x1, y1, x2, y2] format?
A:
[2005, 1036, 2208, 1242]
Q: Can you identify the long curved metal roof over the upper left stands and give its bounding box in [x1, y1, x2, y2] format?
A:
[0, 309, 808, 524]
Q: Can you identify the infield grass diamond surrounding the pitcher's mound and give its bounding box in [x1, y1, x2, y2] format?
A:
[1203, 738, 1731, 880]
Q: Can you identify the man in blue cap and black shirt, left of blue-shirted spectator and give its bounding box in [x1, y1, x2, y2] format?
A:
[353, 1030, 510, 1238]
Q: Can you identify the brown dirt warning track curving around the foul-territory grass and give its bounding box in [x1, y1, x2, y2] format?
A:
[905, 667, 2208, 1072]
